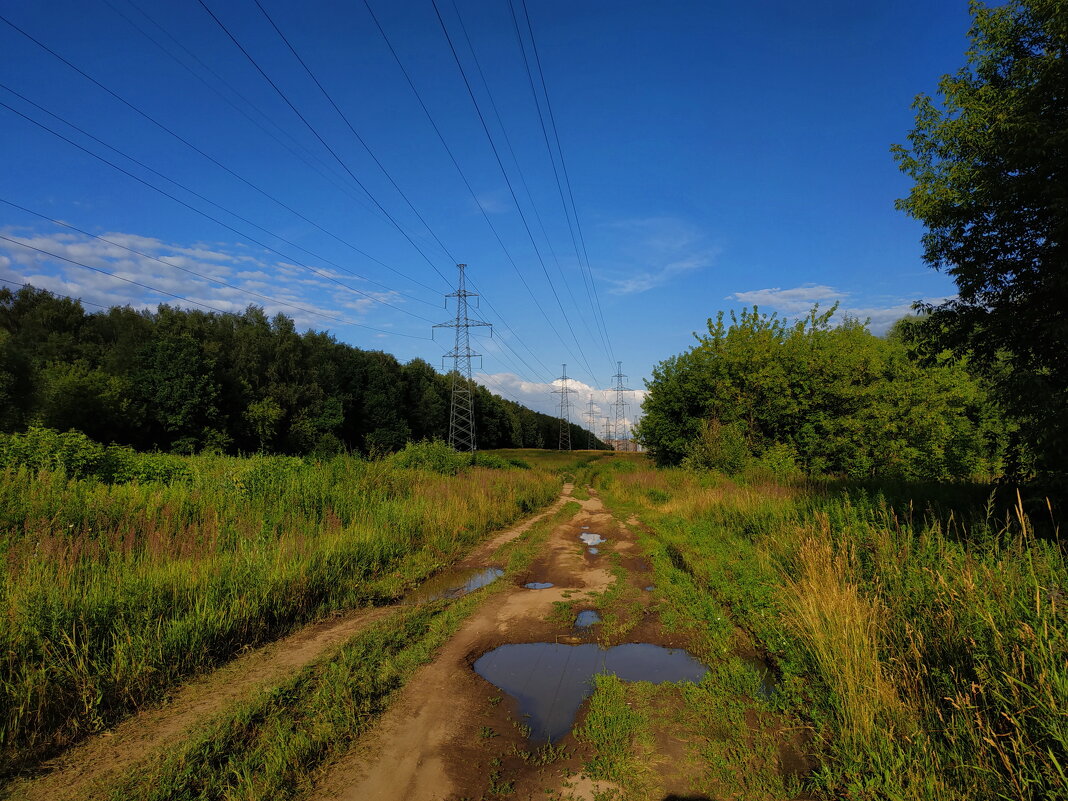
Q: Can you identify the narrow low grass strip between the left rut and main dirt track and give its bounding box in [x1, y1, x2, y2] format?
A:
[98, 503, 578, 801]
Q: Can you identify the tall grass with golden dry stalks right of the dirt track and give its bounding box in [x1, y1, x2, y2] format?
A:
[598, 461, 1068, 801]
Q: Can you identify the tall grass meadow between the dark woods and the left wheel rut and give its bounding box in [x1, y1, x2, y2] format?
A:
[0, 456, 559, 770]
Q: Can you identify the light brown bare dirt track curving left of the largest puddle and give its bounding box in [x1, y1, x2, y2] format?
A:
[313, 489, 661, 801]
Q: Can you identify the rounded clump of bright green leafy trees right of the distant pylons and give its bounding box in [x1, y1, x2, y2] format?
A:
[638, 308, 1001, 478]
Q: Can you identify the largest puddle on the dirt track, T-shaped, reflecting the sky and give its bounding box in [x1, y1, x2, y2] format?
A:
[474, 643, 708, 742]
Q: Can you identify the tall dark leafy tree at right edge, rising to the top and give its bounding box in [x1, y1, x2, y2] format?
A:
[893, 0, 1068, 473]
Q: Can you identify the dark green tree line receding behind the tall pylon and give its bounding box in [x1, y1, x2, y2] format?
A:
[0, 287, 606, 456]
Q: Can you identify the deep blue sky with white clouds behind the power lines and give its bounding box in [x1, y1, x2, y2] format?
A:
[0, 0, 969, 429]
